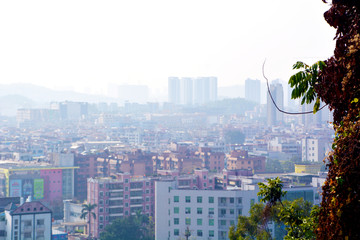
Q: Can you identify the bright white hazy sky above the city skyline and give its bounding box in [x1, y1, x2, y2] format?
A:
[0, 0, 335, 93]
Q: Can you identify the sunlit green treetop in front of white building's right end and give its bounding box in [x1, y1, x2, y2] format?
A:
[229, 178, 319, 240]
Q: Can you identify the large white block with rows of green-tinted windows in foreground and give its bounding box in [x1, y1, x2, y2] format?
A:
[155, 181, 258, 240]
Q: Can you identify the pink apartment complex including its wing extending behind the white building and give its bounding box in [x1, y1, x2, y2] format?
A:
[87, 169, 216, 237]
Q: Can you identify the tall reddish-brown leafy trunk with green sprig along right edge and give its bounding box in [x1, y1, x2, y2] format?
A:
[289, 0, 360, 239]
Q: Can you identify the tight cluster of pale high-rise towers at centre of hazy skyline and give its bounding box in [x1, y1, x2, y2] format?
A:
[168, 77, 217, 106]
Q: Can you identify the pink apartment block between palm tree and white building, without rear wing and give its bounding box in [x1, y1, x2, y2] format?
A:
[87, 173, 155, 237]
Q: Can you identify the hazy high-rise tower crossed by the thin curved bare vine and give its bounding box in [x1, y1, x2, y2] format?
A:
[267, 81, 284, 126]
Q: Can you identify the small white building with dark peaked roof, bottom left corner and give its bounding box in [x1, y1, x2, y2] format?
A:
[5, 202, 52, 240]
